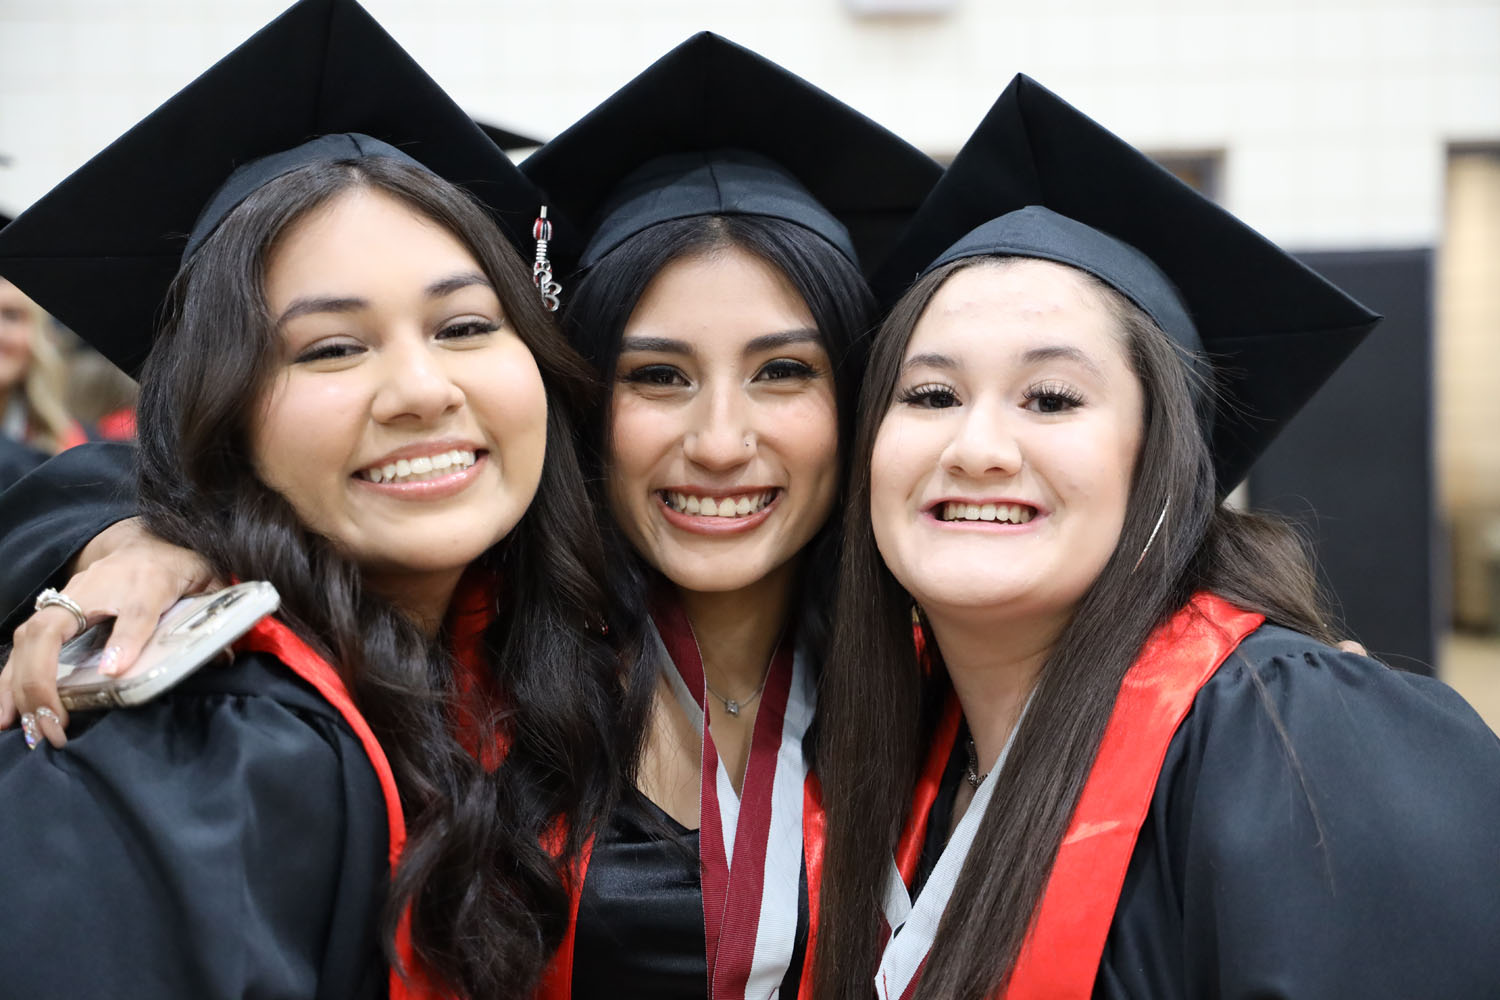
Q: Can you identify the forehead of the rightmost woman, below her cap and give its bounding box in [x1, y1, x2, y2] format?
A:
[906, 259, 1124, 358]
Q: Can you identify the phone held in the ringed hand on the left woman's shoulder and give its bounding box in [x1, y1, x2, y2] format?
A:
[57, 580, 281, 712]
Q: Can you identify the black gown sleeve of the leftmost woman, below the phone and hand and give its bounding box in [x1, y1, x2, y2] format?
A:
[0, 657, 387, 1000]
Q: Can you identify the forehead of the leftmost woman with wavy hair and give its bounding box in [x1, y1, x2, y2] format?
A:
[266, 187, 480, 303]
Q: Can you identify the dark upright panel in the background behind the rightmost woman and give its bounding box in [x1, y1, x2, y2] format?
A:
[1250, 249, 1448, 673]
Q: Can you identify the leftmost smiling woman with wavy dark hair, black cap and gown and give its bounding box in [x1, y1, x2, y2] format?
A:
[0, 0, 620, 999]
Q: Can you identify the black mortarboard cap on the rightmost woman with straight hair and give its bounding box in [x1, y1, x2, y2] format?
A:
[875, 75, 1380, 493]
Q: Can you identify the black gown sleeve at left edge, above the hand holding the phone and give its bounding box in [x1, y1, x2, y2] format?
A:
[0, 444, 137, 637]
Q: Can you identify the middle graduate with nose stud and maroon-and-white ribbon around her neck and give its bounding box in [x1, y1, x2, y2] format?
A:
[2, 34, 939, 999]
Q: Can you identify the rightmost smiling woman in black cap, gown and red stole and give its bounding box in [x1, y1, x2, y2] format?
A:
[815, 76, 1500, 1000]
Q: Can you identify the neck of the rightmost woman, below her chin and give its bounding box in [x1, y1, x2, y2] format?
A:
[927, 609, 1067, 774]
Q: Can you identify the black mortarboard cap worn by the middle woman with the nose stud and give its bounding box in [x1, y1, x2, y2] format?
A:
[522, 31, 942, 273]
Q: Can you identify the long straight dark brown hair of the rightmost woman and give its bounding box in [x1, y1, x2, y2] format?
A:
[815, 258, 1331, 1000]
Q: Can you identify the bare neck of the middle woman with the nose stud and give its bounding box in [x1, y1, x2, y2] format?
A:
[675, 559, 797, 697]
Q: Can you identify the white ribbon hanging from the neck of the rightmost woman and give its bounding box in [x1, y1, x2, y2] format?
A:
[875, 697, 1031, 1000]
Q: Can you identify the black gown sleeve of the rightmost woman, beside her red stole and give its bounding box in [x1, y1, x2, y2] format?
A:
[1095, 627, 1500, 1000]
